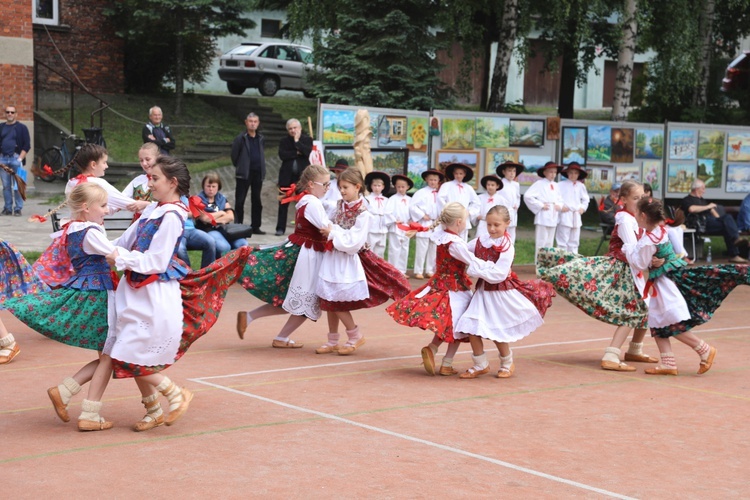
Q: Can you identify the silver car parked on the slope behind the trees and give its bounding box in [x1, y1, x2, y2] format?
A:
[219, 42, 314, 97]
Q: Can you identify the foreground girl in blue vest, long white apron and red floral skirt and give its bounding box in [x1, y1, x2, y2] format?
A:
[78, 156, 250, 431]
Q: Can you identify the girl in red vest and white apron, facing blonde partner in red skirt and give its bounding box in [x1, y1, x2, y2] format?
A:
[455, 205, 555, 379]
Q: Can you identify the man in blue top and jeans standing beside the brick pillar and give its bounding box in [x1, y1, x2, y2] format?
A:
[0, 106, 31, 216]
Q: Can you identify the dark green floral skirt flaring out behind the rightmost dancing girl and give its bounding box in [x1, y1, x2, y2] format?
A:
[651, 264, 750, 338]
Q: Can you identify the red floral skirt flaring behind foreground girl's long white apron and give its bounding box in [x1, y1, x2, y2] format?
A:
[112, 247, 252, 378]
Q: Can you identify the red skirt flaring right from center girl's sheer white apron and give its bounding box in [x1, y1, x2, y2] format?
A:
[320, 250, 411, 311]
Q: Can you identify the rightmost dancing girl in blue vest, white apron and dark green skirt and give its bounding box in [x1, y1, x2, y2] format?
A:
[624, 199, 749, 375]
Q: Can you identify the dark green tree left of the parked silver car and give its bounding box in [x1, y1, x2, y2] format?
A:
[105, 0, 255, 115]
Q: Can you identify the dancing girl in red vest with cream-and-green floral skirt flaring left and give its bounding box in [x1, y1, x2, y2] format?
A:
[537, 181, 663, 372]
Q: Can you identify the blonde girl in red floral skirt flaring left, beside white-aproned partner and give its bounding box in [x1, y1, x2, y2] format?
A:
[386, 202, 496, 375]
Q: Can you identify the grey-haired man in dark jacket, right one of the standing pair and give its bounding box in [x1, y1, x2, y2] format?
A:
[276, 118, 312, 236]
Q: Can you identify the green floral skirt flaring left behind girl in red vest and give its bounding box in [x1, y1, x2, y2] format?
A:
[239, 245, 300, 307]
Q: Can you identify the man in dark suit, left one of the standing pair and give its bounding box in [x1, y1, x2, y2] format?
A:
[232, 113, 266, 234]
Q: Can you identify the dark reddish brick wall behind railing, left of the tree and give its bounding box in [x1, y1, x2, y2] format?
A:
[33, 0, 125, 94]
